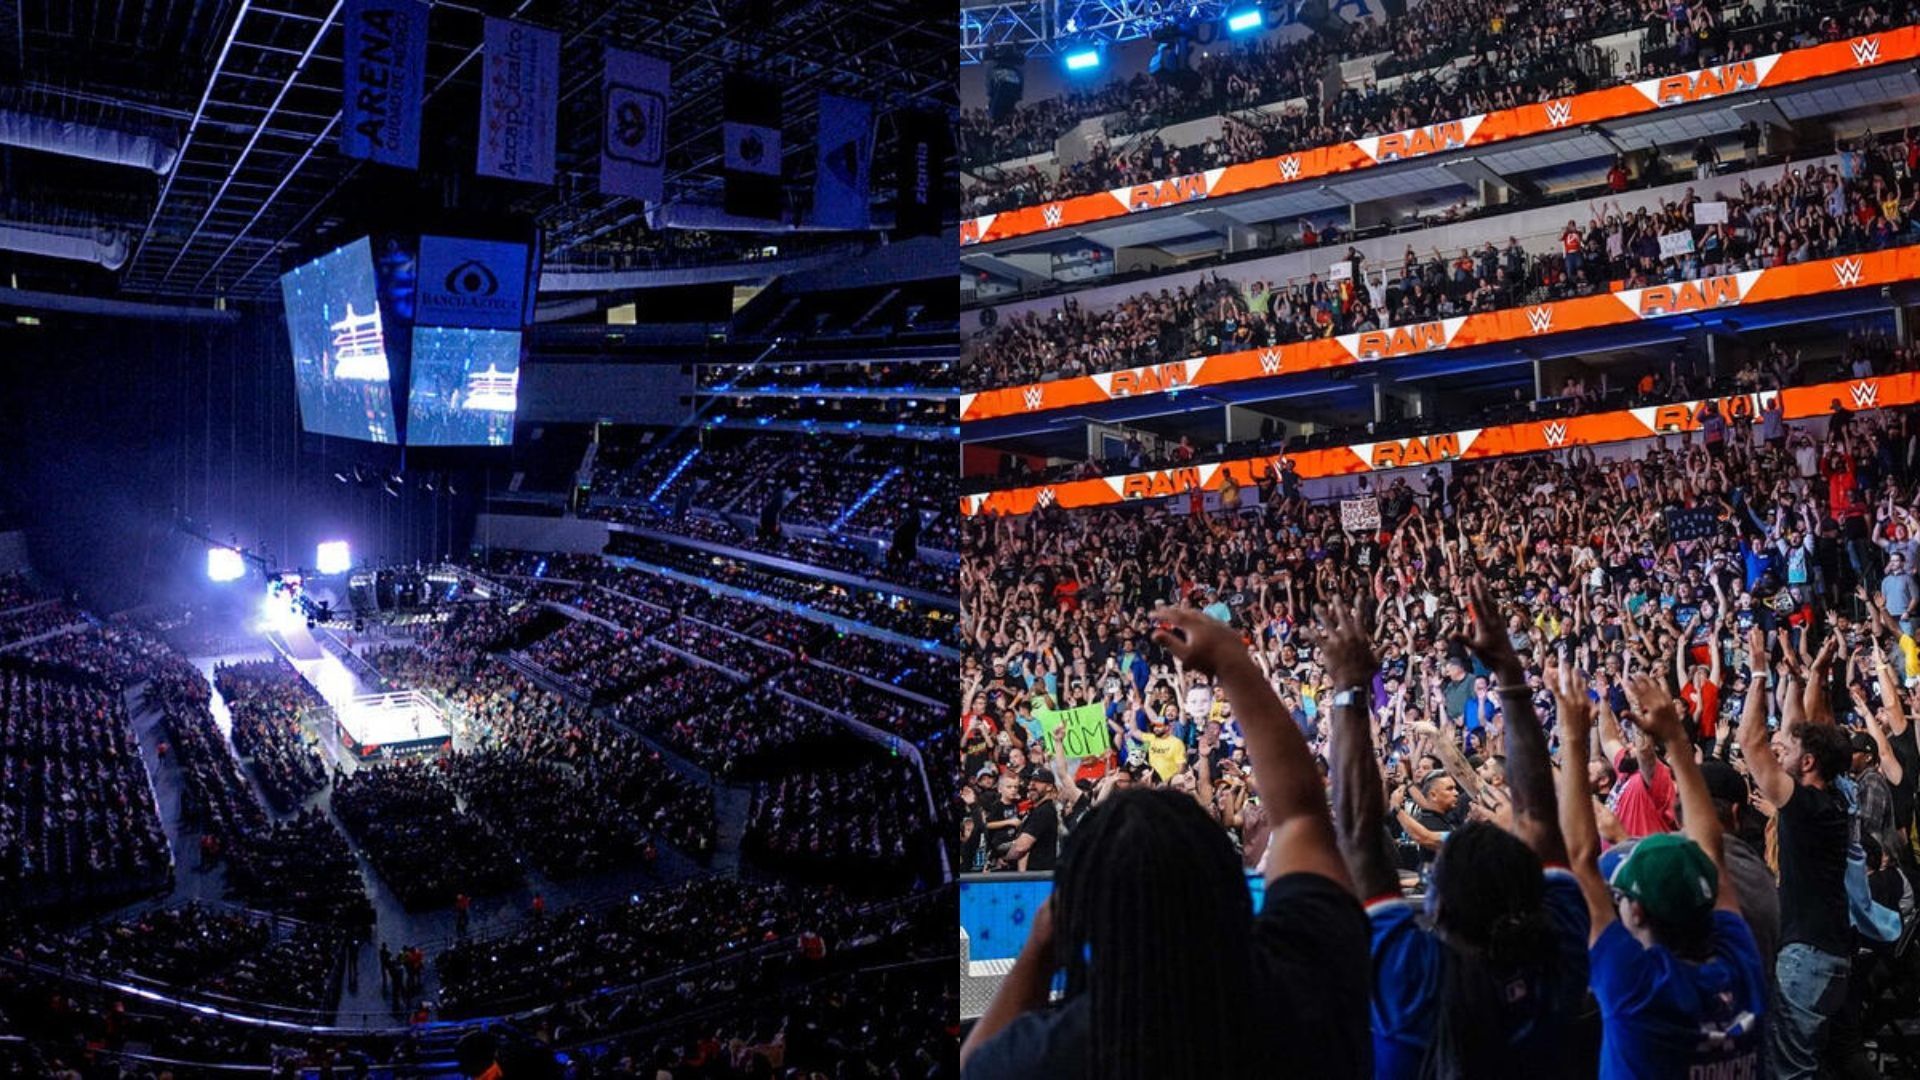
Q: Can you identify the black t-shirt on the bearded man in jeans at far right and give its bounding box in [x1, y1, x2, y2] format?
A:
[1776, 784, 1851, 957]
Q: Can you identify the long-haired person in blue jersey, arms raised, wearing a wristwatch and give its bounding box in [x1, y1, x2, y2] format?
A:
[1319, 578, 1592, 1080]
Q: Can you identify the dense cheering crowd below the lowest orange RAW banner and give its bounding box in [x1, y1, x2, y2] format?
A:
[958, 397, 1920, 1074]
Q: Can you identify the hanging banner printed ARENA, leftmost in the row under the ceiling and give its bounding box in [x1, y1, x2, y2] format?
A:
[340, 0, 426, 169]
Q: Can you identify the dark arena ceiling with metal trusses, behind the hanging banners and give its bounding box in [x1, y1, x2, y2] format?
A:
[0, 0, 956, 300]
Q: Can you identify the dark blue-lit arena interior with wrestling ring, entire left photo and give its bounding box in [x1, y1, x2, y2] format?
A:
[0, 0, 960, 1080]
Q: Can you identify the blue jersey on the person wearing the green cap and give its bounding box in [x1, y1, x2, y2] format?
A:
[1594, 911, 1766, 1080]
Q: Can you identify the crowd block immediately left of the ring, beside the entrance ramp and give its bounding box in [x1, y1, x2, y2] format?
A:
[213, 657, 332, 813]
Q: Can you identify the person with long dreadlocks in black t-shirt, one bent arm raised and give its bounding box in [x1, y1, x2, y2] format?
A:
[960, 609, 1373, 1080]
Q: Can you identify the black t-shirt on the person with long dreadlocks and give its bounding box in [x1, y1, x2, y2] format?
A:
[962, 872, 1373, 1080]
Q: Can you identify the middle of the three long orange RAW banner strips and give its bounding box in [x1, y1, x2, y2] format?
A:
[960, 246, 1920, 421]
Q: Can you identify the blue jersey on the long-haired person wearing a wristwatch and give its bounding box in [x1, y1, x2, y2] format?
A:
[1367, 867, 1592, 1080]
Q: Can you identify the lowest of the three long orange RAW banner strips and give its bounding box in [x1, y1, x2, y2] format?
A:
[960, 373, 1920, 515]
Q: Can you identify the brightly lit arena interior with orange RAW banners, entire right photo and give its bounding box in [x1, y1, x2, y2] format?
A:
[967, 0, 1920, 1076]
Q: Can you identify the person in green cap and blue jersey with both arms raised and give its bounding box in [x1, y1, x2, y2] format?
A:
[1548, 628, 1768, 1080]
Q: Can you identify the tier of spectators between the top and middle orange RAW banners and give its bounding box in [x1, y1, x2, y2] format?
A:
[964, 136, 1920, 386]
